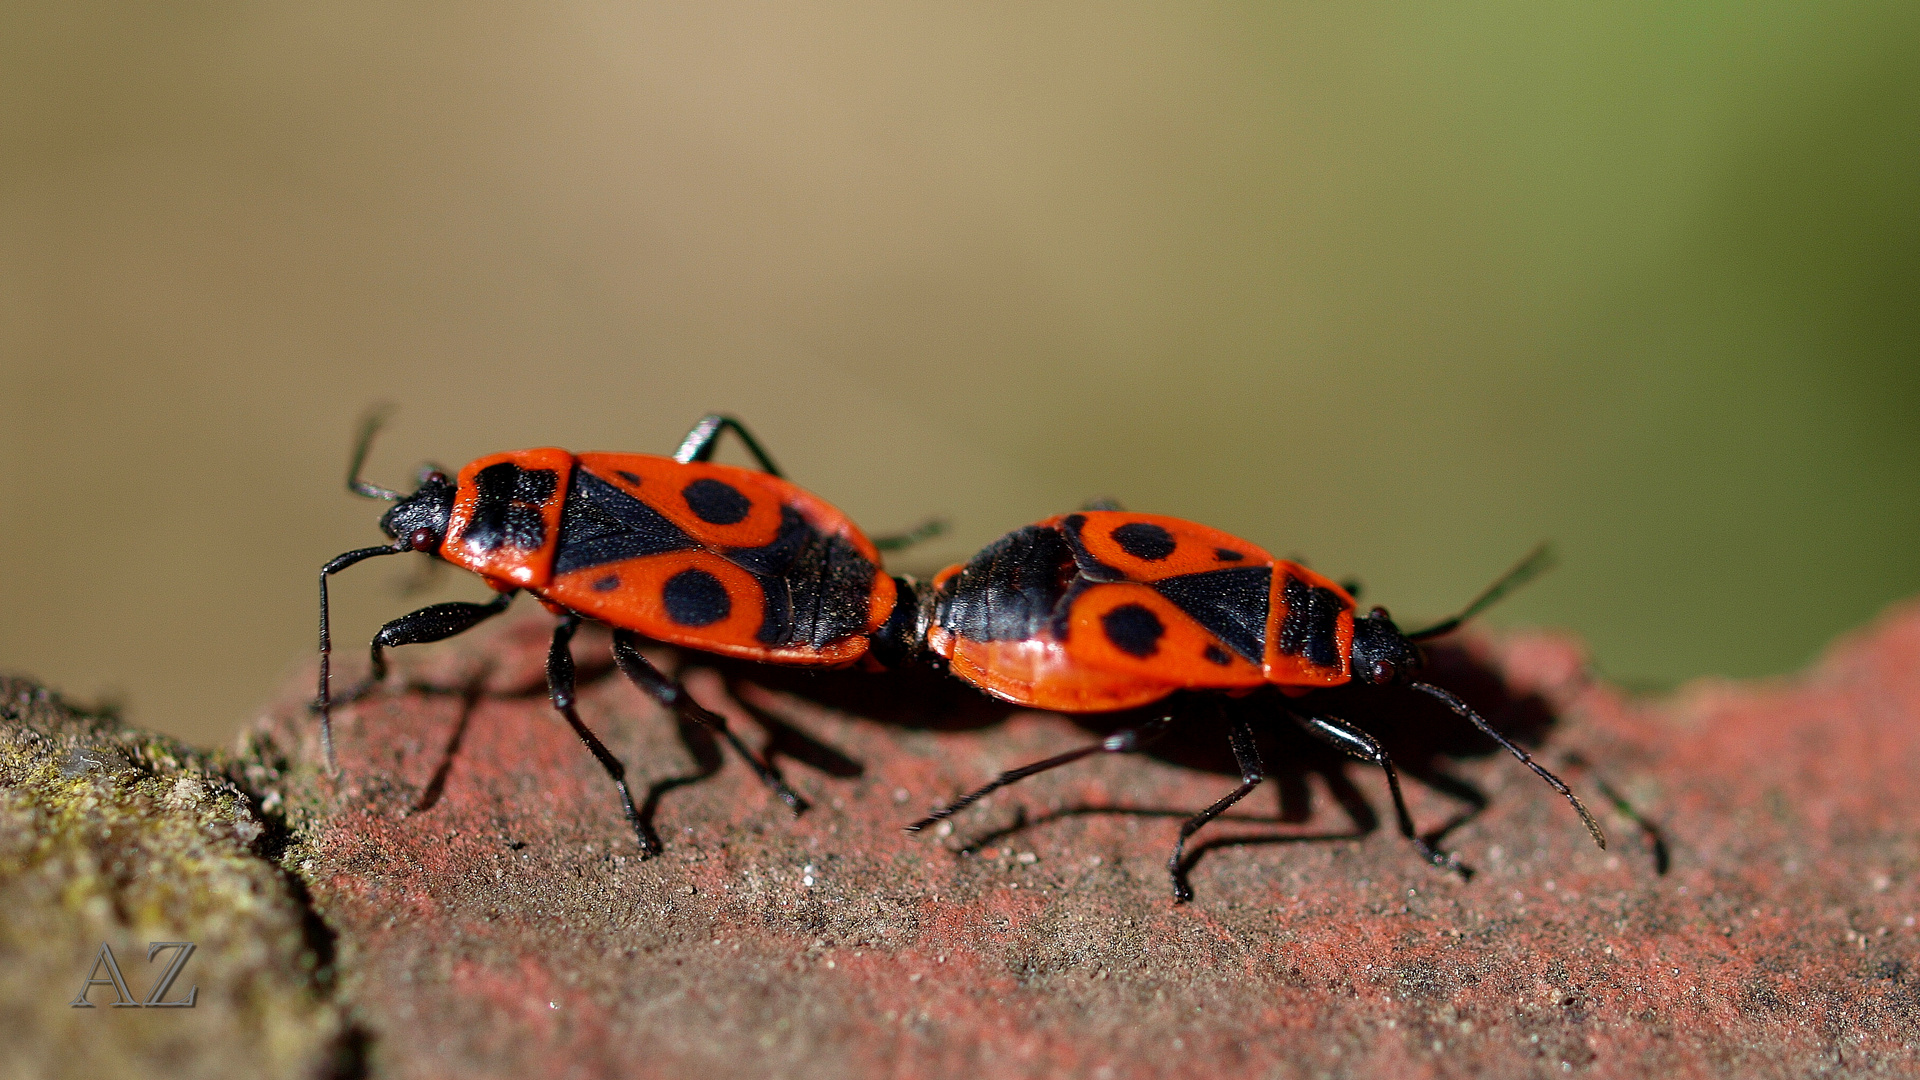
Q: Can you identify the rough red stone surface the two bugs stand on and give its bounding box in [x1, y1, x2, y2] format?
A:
[247, 607, 1920, 1078]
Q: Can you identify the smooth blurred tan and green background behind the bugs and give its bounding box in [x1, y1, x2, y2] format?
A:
[0, 0, 1920, 742]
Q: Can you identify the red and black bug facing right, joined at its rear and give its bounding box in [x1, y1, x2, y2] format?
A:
[874, 509, 1607, 901]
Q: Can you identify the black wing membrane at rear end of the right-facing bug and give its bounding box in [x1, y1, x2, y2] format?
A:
[941, 515, 1082, 642]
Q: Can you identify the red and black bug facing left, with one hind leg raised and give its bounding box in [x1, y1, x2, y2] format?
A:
[315, 415, 939, 855]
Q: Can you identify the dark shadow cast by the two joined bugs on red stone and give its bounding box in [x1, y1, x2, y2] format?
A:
[397, 626, 1668, 878]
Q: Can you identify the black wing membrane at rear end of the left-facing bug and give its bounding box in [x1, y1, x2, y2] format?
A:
[726, 505, 879, 648]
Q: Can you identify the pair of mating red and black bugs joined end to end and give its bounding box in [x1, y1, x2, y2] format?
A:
[315, 415, 1605, 899]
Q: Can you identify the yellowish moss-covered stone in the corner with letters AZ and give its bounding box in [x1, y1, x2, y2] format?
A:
[0, 678, 357, 1076]
